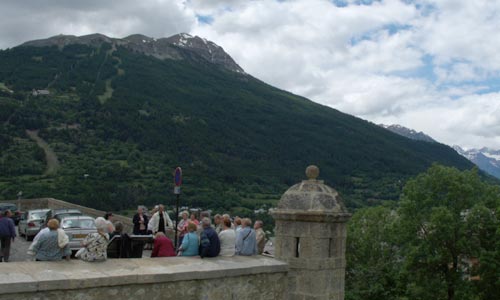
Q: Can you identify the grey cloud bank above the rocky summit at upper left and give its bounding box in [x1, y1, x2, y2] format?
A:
[0, 0, 197, 48]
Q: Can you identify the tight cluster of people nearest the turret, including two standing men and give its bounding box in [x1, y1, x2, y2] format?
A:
[133, 205, 266, 258]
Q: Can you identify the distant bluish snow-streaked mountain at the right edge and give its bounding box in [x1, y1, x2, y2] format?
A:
[453, 145, 500, 178]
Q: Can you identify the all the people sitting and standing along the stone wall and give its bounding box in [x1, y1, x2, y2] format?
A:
[0, 205, 266, 262]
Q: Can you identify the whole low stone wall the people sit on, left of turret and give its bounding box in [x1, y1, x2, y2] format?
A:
[0, 256, 288, 300]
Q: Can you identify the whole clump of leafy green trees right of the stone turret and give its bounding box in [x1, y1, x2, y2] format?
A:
[347, 165, 500, 300]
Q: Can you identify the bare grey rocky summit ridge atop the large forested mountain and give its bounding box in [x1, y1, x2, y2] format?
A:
[21, 33, 245, 74]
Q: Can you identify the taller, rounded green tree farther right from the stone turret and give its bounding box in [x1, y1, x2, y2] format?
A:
[397, 165, 500, 300]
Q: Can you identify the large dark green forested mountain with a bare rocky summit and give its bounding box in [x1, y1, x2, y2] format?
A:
[0, 34, 473, 211]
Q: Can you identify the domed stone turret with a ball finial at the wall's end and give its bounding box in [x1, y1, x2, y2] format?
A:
[271, 166, 351, 300]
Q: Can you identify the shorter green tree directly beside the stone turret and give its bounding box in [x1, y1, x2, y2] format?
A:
[346, 206, 402, 300]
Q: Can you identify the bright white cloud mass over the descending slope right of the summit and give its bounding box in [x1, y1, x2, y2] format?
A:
[194, 0, 500, 147]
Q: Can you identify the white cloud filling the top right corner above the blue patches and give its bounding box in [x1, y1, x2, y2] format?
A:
[415, 0, 500, 70]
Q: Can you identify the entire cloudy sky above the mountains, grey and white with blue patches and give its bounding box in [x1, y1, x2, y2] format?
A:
[0, 0, 500, 149]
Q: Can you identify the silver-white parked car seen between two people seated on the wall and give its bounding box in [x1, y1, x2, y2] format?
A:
[56, 215, 97, 252]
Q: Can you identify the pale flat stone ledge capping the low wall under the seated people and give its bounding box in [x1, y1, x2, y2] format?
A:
[0, 256, 288, 294]
